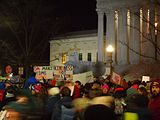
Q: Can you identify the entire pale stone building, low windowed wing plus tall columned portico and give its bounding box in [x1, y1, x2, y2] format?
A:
[50, 0, 160, 75]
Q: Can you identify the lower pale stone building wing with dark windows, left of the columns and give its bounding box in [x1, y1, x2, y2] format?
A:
[50, 30, 98, 65]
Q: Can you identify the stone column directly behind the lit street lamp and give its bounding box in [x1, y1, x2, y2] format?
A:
[106, 10, 116, 64]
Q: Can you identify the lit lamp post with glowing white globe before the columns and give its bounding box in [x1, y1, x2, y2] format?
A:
[106, 45, 114, 75]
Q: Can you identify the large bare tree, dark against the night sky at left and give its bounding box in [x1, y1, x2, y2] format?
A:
[0, 0, 66, 77]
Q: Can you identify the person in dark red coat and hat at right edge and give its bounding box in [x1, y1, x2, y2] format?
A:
[148, 79, 160, 120]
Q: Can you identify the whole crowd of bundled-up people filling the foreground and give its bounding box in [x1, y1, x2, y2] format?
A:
[0, 66, 160, 120]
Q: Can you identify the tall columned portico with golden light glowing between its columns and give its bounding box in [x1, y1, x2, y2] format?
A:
[96, 0, 160, 65]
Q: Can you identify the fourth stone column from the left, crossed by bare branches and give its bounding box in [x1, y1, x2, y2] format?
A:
[129, 7, 141, 64]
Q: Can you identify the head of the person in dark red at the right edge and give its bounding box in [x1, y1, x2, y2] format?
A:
[150, 79, 160, 97]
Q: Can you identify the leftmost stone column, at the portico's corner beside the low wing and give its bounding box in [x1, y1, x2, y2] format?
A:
[97, 11, 104, 62]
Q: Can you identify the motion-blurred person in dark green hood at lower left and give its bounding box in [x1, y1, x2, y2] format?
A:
[5, 89, 42, 120]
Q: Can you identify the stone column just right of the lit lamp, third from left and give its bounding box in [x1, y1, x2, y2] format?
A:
[117, 8, 128, 65]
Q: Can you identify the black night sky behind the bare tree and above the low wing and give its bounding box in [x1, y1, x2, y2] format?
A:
[0, 0, 97, 64]
